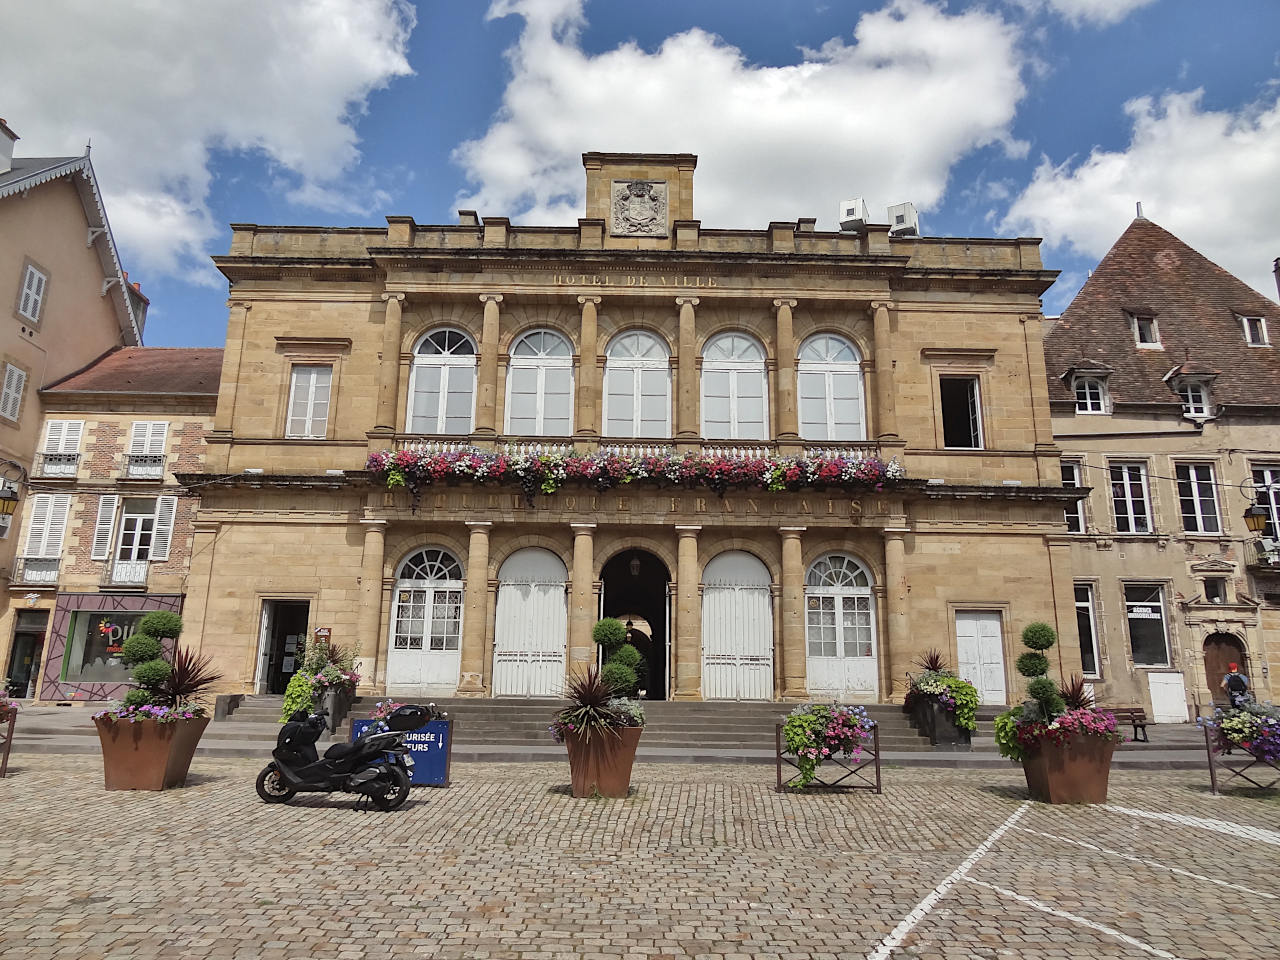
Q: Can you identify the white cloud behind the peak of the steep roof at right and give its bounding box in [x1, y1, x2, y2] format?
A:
[1001, 91, 1280, 298]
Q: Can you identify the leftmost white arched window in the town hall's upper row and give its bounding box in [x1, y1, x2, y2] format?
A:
[407, 329, 476, 434]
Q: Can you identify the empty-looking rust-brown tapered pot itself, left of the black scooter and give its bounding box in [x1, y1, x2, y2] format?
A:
[93, 717, 209, 790]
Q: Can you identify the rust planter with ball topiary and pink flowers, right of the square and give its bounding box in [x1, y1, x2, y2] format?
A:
[996, 623, 1124, 804]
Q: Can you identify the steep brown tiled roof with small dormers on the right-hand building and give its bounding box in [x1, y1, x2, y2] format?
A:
[1044, 218, 1280, 404]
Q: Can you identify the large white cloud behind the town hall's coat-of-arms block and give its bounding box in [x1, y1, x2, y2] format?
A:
[454, 0, 1025, 228]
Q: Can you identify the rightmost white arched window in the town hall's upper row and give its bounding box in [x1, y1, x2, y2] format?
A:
[796, 333, 867, 442]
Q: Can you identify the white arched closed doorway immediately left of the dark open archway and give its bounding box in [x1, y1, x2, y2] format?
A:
[493, 547, 568, 696]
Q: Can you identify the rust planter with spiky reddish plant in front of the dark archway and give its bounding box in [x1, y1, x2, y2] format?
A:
[548, 667, 645, 797]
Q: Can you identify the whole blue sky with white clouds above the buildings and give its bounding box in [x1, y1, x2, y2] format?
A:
[0, 0, 1280, 346]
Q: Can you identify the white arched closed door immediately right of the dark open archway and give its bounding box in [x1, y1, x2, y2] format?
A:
[703, 550, 773, 700]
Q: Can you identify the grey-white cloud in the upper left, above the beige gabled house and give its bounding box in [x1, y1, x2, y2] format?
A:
[0, 0, 413, 282]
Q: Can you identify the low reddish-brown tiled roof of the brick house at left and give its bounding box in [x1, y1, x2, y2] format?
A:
[44, 347, 223, 397]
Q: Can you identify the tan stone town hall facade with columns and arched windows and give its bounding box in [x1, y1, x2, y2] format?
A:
[182, 154, 1080, 701]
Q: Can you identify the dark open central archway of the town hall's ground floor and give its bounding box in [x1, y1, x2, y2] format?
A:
[600, 549, 671, 700]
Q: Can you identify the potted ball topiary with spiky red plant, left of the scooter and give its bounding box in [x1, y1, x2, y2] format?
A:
[93, 611, 221, 790]
